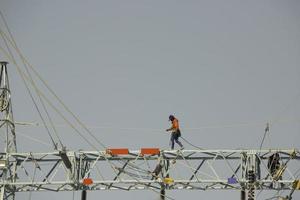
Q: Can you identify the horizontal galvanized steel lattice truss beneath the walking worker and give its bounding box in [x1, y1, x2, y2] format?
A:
[0, 150, 300, 192]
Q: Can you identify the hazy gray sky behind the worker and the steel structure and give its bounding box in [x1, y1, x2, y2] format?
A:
[0, 0, 300, 200]
